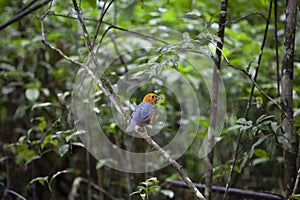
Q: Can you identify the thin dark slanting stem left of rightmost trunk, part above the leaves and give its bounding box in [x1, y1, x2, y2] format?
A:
[245, 0, 273, 119]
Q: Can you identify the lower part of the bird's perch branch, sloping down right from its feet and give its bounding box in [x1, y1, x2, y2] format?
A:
[137, 127, 205, 199]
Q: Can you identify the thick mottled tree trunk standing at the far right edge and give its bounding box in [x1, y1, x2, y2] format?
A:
[281, 0, 298, 199]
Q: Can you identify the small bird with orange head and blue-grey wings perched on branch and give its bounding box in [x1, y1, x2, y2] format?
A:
[125, 93, 162, 133]
